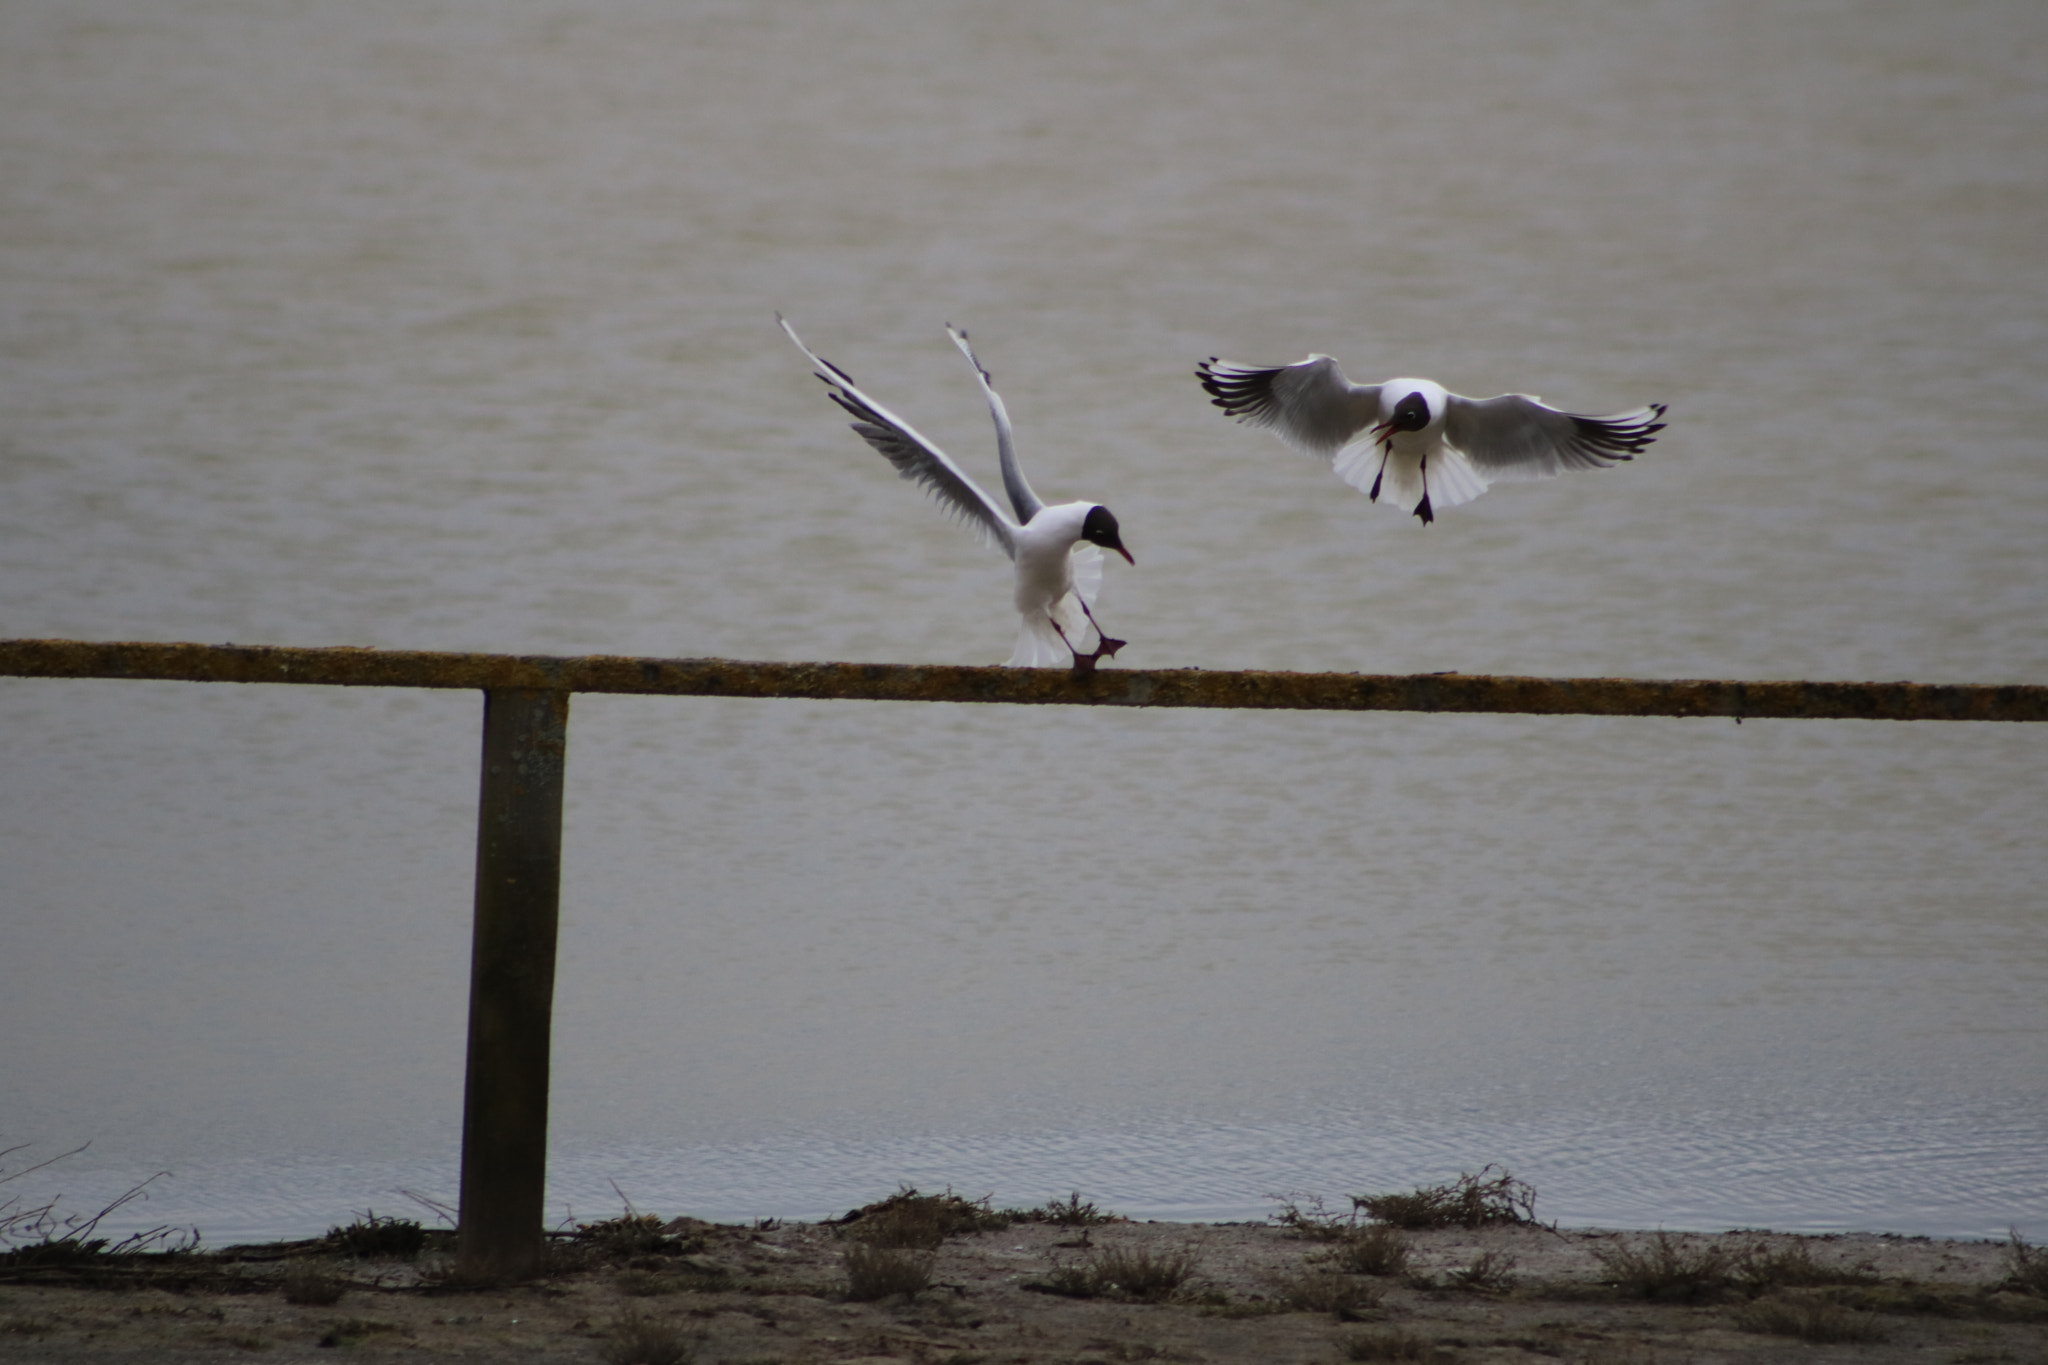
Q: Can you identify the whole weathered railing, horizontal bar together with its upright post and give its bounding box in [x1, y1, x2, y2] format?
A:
[0, 641, 2048, 1283]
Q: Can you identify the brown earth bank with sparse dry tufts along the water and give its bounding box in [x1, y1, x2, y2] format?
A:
[0, 1218, 2048, 1365]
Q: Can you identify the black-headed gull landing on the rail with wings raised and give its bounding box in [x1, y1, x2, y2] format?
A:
[776, 313, 1137, 677]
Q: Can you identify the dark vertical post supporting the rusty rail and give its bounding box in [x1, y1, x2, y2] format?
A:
[455, 688, 569, 1283]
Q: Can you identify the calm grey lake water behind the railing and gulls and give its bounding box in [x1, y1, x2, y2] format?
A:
[0, 0, 2048, 1240]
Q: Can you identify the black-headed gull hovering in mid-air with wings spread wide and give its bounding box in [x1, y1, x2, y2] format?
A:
[1194, 356, 1665, 522]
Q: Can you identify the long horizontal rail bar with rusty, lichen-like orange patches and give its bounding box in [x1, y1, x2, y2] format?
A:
[0, 641, 2048, 720]
